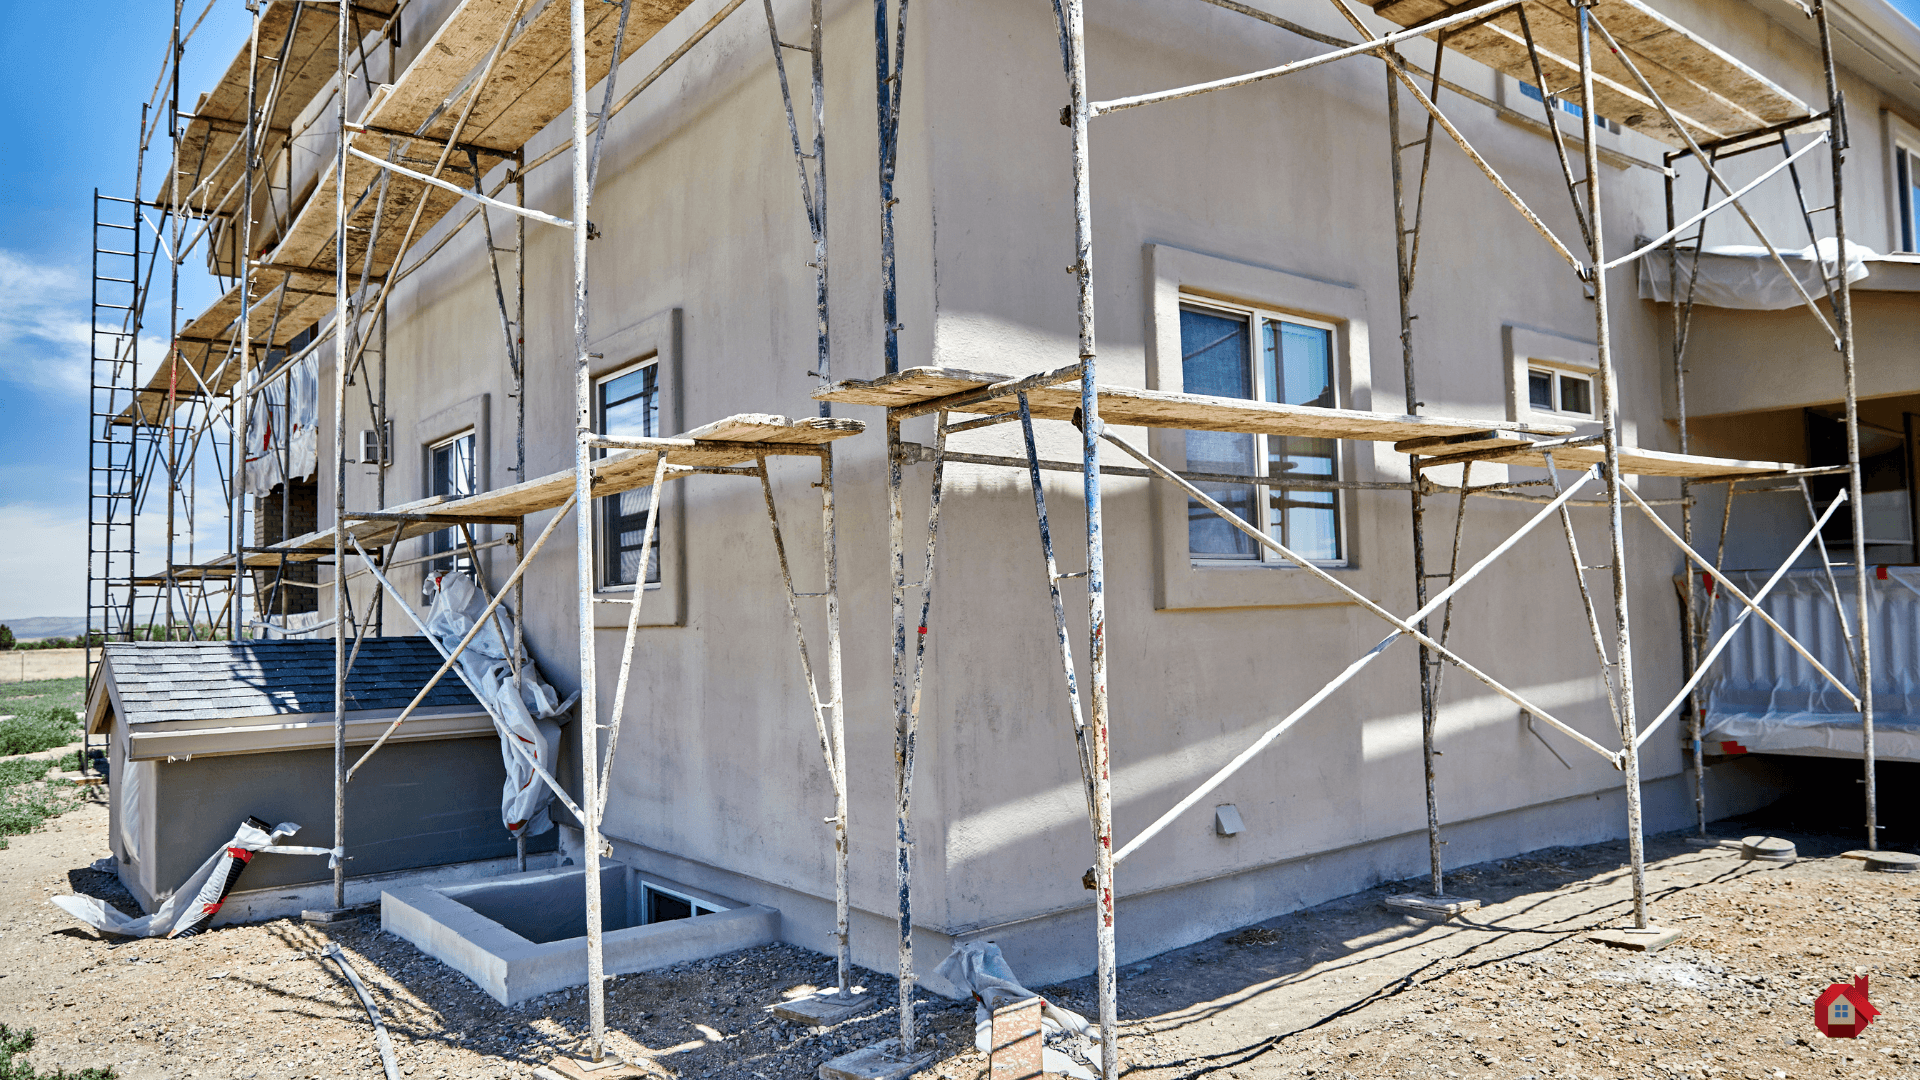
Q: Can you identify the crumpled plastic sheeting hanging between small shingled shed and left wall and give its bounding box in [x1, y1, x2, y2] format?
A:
[426, 573, 572, 836]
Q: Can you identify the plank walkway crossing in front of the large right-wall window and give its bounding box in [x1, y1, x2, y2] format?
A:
[814, 367, 1572, 441]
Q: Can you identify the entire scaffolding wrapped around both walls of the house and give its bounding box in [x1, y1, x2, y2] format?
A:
[88, 0, 1876, 1080]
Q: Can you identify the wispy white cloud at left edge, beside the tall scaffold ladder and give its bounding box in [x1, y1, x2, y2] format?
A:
[0, 250, 92, 398]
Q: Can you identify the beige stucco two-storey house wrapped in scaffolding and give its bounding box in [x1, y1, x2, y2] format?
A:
[88, 0, 1920, 1076]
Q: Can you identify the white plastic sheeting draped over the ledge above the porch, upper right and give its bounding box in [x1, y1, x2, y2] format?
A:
[1640, 236, 1878, 311]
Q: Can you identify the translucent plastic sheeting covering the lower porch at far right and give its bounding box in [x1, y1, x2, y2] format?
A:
[1703, 567, 1920, 761]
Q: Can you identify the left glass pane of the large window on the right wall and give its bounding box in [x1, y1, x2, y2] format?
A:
[1181, 307, 1260, 559]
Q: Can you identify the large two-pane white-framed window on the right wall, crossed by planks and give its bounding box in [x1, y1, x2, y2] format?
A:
[1181, 304, 1346, 565]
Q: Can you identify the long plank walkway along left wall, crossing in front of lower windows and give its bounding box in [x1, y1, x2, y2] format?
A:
[220, 413, 866, 567]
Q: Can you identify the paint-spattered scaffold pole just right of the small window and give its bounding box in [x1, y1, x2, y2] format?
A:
[1578, 0, 1647, 930]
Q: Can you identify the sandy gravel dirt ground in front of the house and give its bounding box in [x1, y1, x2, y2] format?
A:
[0, 780, 1920, 1080]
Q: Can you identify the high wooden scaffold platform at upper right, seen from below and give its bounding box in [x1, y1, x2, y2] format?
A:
[1373, 0, 1812, 146]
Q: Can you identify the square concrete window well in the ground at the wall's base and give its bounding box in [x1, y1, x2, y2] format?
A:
[380, 863, 780, 1005]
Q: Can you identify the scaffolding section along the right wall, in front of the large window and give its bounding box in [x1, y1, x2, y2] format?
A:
[802, 0, 1876, 1080]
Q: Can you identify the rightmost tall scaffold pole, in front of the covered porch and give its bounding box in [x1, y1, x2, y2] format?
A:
[1812, 0, 1880, 851]
